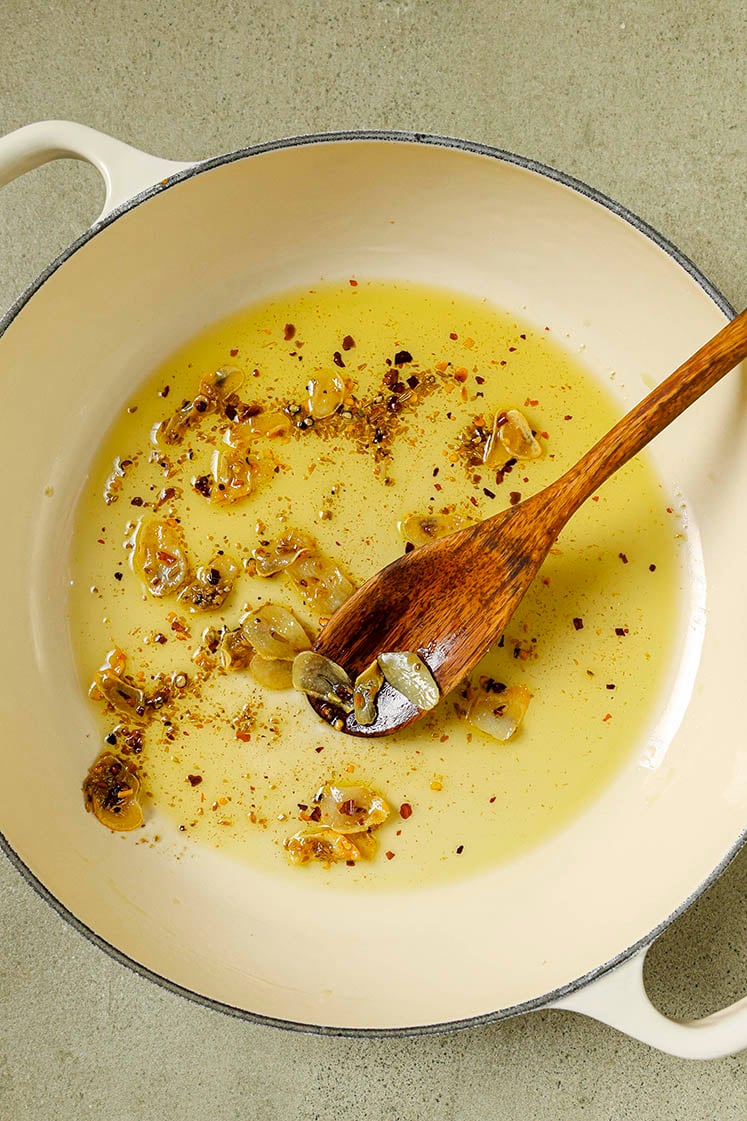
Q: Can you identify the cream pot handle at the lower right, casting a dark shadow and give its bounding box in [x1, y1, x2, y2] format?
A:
[550, 947, 747, 1059]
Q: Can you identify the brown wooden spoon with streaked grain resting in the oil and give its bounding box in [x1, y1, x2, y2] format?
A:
[310, 311, 747, 735]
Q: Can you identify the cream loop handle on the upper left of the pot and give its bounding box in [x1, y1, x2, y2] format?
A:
[0, 121, 194, 221]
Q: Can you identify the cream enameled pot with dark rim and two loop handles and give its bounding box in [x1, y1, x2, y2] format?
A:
[0, 121, 747, 1057]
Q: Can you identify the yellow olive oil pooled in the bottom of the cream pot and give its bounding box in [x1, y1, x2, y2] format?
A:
[70, 280, 682, 889]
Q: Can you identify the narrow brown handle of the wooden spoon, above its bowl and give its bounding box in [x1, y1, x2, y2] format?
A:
[548, 309, 747, 521]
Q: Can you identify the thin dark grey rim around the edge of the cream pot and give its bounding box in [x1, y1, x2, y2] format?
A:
[0, 129, 747, 1039]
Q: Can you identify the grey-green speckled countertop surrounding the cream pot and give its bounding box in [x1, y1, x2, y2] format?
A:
[0, 0, 747, 1121]
